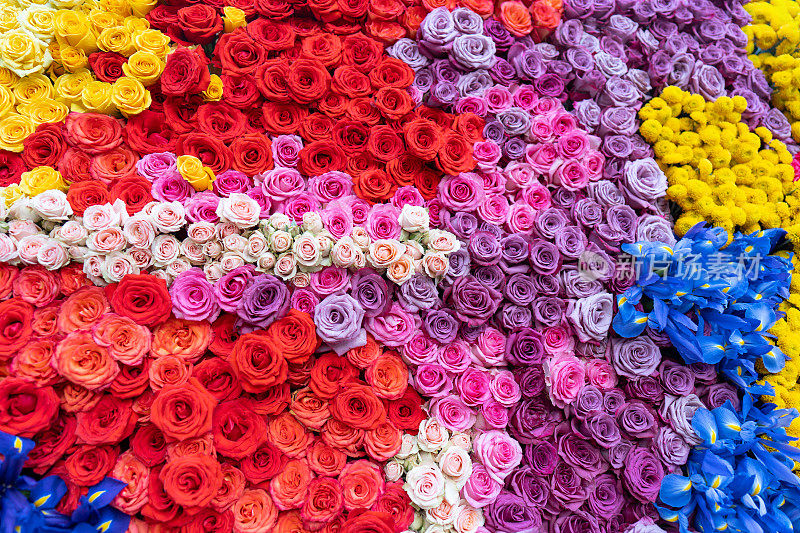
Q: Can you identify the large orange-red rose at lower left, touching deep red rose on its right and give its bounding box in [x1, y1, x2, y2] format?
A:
[150, 378, 217, 441]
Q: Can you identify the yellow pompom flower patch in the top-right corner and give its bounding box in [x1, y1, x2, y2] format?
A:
[744, 0, 800, 142]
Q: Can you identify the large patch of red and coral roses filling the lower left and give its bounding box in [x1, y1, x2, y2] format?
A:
[0, 264, 425, 533]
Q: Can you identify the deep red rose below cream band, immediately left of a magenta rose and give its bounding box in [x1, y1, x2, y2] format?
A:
[106, 274, 172, 327]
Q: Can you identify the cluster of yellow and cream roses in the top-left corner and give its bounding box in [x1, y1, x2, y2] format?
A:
[0, 0, 170, 152]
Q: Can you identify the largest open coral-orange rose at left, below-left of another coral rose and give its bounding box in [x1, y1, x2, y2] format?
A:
[53, 331, 119, 391]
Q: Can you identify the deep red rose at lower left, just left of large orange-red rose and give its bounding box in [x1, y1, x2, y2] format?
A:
[75, 394, 137, 444]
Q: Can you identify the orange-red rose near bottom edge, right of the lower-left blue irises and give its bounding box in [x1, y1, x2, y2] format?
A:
[159, 455, 222, 507]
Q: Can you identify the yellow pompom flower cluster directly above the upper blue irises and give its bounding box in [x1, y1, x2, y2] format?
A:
[639, 86, 800, 240]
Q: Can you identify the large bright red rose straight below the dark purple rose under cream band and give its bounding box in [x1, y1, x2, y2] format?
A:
[230, 331, 289, 392]
